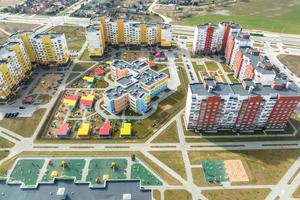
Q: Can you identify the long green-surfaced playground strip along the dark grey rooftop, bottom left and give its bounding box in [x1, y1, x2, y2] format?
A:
[7, 157, 163, 188]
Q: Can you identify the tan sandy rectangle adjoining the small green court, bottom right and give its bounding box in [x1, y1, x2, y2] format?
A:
[224, 160, 249, 182]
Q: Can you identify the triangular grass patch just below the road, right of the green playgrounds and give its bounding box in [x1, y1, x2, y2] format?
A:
[149, 151, 186, 179]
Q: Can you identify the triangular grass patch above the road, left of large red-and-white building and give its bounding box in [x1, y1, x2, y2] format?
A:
[152, 122, 179, 143]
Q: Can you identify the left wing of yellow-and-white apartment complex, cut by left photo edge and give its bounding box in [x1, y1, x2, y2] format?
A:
[0, 41, 32, 100]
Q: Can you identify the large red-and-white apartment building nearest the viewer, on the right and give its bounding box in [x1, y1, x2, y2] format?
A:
[185, 79, 300, 131]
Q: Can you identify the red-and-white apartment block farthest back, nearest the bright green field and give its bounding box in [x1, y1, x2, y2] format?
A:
[193, 22, 241, 55]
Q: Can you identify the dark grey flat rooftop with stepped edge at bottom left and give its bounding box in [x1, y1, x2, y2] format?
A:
[0, 180, 152, 200]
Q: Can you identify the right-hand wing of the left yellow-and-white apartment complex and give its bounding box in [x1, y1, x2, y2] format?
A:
[33, 32, 70, 66]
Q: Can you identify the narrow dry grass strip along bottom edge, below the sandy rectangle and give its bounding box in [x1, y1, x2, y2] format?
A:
[203, 189, 270, 200]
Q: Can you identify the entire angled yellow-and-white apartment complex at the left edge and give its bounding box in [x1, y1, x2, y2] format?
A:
[0, 31, 70, 100]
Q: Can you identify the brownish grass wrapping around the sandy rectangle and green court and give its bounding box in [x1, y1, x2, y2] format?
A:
[189, 149, 300, 184]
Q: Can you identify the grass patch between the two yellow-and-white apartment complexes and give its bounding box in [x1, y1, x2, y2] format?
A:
[51, 26, 85, 51]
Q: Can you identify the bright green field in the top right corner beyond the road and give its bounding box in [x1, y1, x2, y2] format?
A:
[175, 0, 300, 34]
